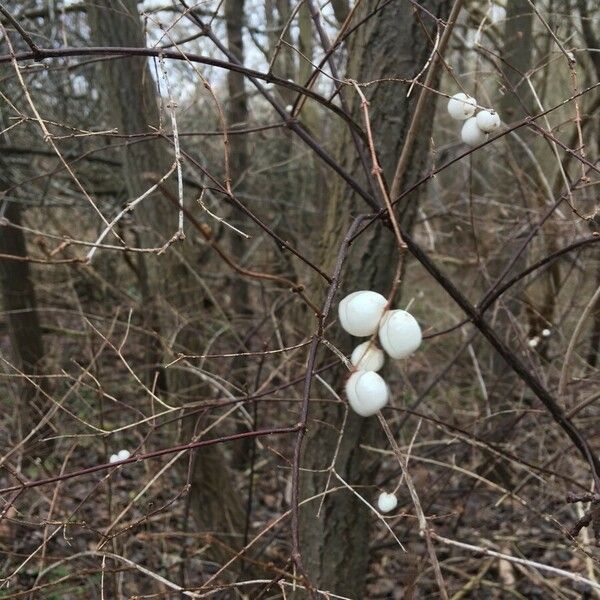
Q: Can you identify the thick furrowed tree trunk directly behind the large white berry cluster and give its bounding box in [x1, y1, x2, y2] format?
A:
[301, 0, 450, 599]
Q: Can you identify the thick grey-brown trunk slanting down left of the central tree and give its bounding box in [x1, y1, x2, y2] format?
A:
[86, 0, 243, 562]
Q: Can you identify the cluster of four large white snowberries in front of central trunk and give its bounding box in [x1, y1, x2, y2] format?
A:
[339, 290, 423, 417]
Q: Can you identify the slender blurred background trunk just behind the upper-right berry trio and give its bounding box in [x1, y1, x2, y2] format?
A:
[472, 0, 543, 485]
